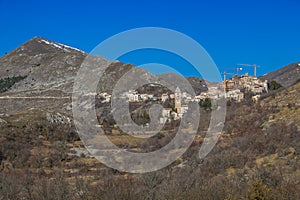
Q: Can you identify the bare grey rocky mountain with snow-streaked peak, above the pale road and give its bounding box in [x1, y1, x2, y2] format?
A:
[0, 37, 87, 93]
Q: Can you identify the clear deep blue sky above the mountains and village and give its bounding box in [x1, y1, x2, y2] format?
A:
[0, 0, 300, 76]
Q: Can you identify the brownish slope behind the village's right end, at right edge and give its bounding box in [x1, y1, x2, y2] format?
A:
[260, 62, 300, 87]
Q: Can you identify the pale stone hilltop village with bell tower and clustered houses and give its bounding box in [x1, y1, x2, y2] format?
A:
[96, 73, 269, 124]
